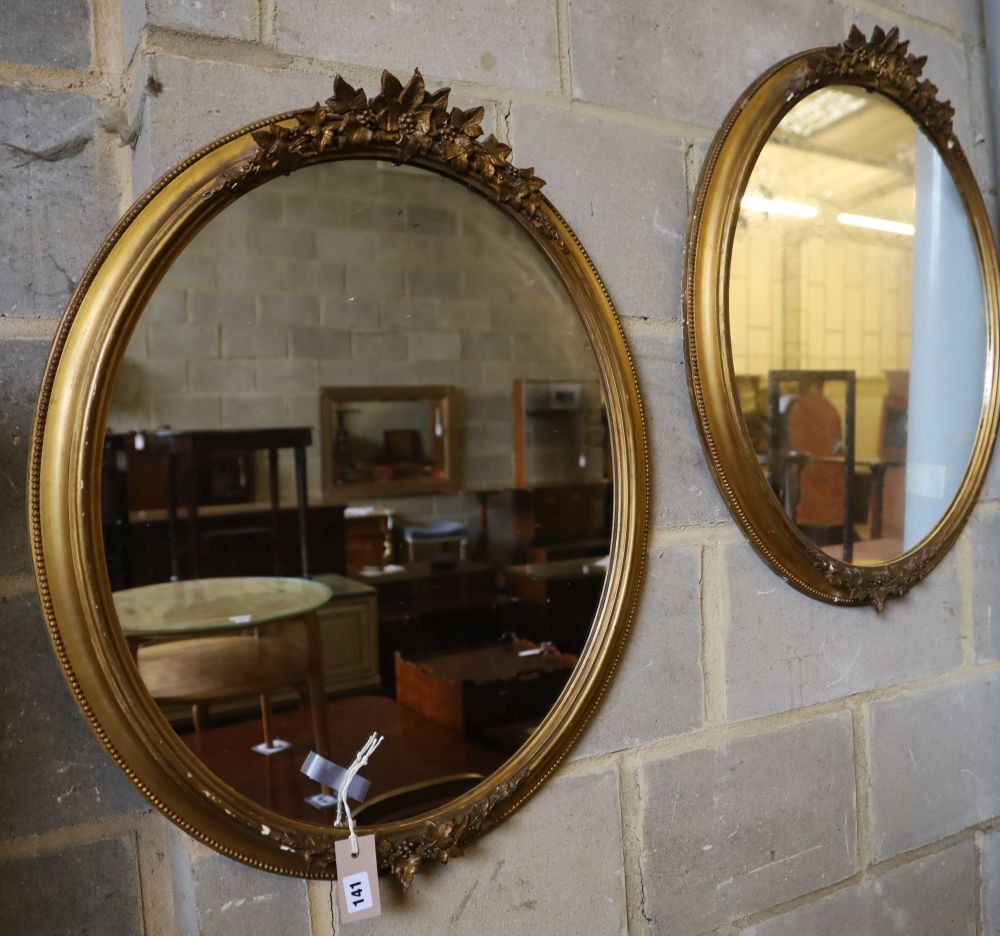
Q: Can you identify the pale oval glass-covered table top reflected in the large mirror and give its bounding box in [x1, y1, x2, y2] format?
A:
[114, 576, 333, 636]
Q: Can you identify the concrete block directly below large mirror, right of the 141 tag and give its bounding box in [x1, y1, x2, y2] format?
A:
[337, 767, 628, 936]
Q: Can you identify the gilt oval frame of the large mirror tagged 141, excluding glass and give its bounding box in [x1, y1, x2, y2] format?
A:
[29, 72, 649, 886]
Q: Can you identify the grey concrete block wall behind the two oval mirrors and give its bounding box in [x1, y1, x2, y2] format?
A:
[0, 0, 1000, 936]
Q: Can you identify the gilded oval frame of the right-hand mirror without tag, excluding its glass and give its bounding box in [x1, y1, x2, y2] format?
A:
[684, 27, 1000, 611]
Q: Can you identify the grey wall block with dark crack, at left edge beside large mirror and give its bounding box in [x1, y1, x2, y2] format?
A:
[0, 89, 118, 317]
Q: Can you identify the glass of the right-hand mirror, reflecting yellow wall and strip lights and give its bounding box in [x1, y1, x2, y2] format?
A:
[729, 85, 987, 564]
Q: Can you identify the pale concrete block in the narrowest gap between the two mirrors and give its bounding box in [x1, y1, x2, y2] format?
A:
[624, 321, 728, 528]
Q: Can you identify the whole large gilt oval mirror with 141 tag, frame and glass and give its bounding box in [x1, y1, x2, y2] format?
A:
[31, 73, 647, 885]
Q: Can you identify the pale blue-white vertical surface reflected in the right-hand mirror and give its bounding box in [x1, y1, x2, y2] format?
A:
[903, 133, 986, 549]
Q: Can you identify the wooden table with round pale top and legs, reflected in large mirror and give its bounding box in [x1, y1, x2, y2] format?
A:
[114, 576, 332, 755]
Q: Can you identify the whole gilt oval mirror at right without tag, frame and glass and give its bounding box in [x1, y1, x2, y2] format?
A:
[685, 28, 1000, 610]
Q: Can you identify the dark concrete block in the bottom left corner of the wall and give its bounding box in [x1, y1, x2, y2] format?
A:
[0, 835, 143, 936]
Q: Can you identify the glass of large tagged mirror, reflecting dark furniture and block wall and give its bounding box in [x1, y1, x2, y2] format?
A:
[102, 160, 612, 824]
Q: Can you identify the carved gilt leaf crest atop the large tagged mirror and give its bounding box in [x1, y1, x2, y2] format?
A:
[208, 70, 565, 248]
